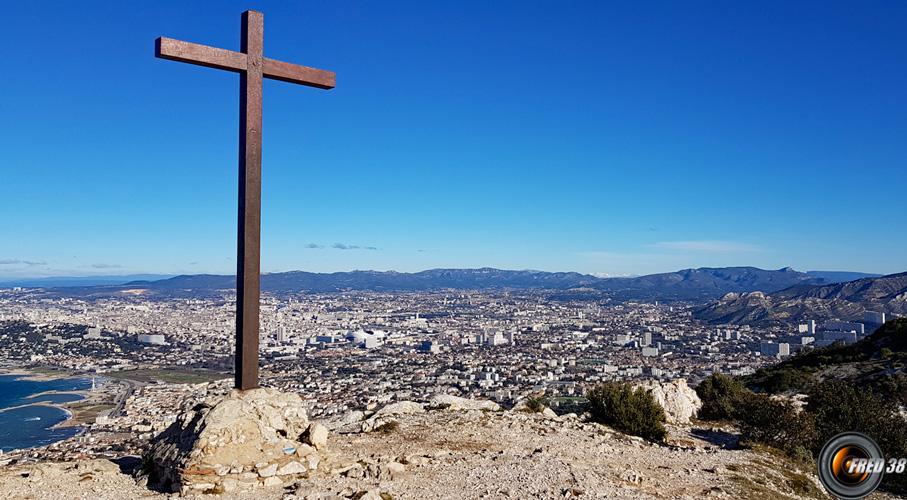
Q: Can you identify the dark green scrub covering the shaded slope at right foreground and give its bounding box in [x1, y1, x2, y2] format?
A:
[696, 319, 907, 491]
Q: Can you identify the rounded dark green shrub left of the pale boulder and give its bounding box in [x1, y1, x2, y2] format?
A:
[586, 382, 667, 441]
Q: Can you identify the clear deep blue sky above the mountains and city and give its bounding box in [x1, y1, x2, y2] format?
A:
[0, 0, 907, 277]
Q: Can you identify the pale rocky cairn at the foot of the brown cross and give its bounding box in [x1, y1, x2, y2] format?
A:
[144, 388, 328, 494]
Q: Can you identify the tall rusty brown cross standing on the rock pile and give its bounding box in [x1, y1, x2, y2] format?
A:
[154, 10, 335, 390]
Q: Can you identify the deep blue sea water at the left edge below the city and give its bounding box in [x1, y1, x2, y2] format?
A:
[0, 375, 91, 452]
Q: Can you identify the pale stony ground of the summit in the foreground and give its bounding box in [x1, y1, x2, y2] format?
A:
[0, 405, 844, 499]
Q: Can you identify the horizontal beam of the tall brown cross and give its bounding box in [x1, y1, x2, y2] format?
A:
[154, 37, 336, 89]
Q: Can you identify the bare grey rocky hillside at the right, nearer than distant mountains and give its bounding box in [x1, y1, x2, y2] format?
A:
[693, 273, 907, 325]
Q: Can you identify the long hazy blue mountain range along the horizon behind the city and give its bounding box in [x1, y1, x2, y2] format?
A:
[7, 267, 873, 302]
